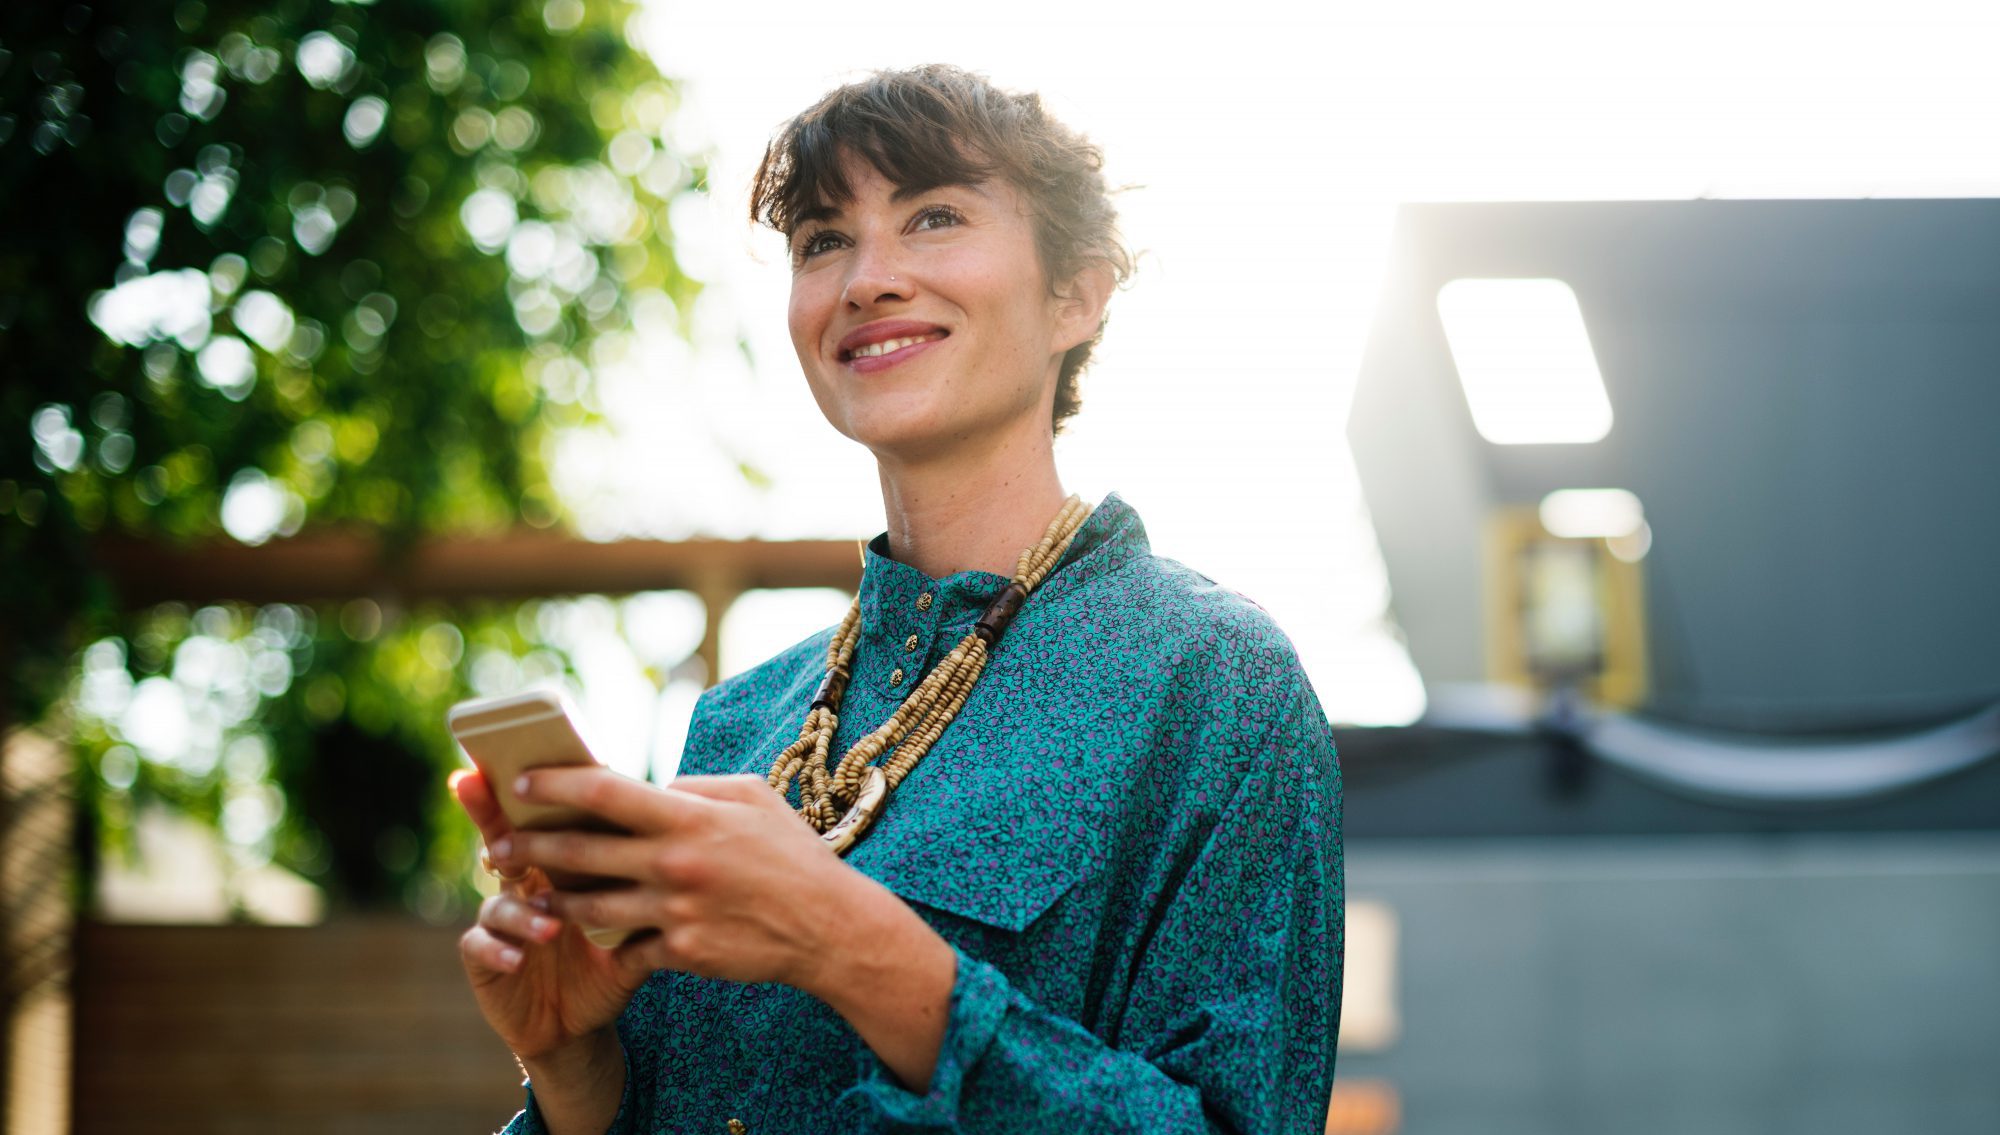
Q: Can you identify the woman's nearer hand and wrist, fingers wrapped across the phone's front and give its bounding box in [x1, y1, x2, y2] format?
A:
[508, 767, 958, 1087]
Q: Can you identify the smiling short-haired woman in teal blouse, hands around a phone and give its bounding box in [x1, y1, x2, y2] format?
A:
[456, 66, 1342, 1133]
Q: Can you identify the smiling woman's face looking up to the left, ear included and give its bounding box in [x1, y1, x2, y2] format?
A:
[790, 158, 1102, 462]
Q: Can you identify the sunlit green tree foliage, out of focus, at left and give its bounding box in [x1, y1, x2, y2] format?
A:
[0, 0, 704, 919]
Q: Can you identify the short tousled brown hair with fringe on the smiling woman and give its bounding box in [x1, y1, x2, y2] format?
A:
[750, 64, 1132, 432]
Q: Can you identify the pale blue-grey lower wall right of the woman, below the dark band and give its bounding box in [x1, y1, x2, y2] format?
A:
[1340, 833, 2000, 1135]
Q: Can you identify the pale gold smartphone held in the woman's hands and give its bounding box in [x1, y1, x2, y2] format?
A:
[444, 689, 628, 947]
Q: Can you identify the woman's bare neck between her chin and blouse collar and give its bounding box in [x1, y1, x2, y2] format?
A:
[880, 421, 1068, 579]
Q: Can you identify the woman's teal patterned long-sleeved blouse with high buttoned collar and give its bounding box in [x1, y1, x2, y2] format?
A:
[508, 496, 1342, 1135]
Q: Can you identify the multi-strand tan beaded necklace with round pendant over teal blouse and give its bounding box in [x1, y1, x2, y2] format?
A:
[766, 496, 1090, 855]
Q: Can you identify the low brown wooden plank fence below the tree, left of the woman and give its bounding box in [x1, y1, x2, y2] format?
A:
[74, 919, 522, 1135]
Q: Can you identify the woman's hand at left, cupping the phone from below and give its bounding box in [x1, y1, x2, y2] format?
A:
[452, 771, 648, 1071]
